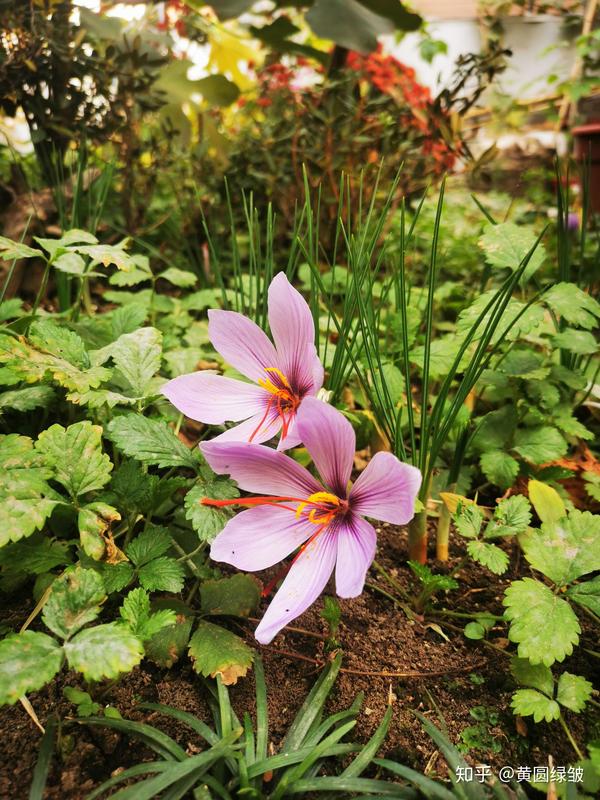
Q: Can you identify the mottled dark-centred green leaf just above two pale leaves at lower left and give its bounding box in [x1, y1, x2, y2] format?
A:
[43, 567, 106, 639]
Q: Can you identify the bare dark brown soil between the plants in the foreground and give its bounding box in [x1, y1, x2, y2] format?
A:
[0, 526, 600, 800]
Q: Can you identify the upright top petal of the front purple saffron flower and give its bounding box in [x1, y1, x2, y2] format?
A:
[296, 397, 356, 497]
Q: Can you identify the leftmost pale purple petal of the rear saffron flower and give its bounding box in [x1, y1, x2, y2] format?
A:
[160, 372, 267, 425]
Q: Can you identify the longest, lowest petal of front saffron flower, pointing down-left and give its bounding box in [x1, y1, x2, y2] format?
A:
[254, 530, 336, 644]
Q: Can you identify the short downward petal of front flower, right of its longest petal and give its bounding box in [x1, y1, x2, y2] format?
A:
[335, 514, 377, 597]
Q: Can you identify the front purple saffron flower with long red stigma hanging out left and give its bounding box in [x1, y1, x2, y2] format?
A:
[200, 397, 421, 644]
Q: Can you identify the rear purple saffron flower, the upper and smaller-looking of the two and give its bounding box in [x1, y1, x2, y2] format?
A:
[161, 272, 323, 450]
